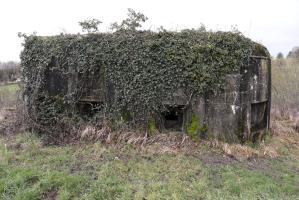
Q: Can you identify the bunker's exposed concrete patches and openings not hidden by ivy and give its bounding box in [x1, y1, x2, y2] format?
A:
[46, 44, 271, 142]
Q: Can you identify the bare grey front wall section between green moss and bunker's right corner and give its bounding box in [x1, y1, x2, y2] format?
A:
[195, 74, 248, 142]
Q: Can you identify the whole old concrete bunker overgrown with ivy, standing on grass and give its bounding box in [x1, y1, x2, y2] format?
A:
[22, 31, 271, 142]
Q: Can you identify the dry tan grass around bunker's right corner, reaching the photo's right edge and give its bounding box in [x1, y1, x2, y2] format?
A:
[206, 111, 299, 161]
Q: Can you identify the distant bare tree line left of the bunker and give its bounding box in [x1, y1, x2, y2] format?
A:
[0, 61, 20, 83]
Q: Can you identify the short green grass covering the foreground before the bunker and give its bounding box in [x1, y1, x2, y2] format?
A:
[0, 134, 299, 200]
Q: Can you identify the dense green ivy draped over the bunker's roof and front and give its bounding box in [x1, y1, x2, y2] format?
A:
[21, 10, 270, 141]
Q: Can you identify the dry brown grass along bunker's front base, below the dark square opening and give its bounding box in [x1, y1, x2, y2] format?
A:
[80, 123, 198, 154]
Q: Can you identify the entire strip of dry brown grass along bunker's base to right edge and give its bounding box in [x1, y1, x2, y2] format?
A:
[81, 110, 299, 161]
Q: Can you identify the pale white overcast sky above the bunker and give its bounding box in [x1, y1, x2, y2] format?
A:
[0, 0, 299, 61]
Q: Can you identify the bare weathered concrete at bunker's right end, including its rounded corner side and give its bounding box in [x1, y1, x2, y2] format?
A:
[192, 57, 271, 142]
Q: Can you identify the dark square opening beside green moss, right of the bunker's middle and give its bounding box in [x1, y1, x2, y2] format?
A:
[163, 106, 184, 131]
